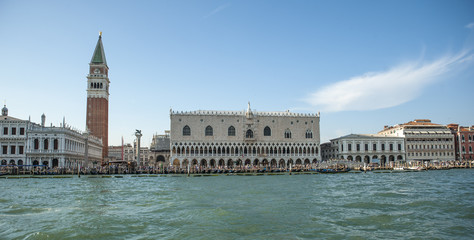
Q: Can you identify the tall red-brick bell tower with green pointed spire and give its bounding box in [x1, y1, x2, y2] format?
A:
[86, 32, 110, 163]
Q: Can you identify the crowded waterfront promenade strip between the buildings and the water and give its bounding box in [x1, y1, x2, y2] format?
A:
[0, 161, 472, 176]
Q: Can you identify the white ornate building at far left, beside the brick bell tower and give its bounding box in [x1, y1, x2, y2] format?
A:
[0, 107, 102, 168]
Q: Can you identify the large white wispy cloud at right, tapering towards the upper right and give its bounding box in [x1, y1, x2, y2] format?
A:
[306, 50, 473, 112]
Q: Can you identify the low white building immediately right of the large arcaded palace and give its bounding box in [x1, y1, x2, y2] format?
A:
[329, 134, 406, 166]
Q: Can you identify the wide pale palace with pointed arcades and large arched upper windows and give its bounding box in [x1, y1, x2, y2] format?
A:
[170, 103, 321, 167]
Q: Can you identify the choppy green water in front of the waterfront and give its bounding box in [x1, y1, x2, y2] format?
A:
[0, 169, 474, 239]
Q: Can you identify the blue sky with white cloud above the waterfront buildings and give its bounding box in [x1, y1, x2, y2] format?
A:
[0, 0, 474, 146]
